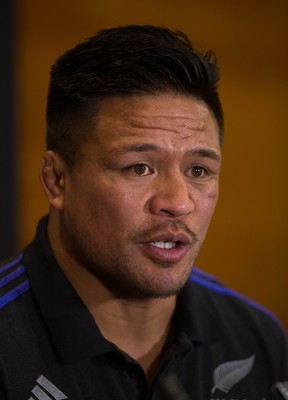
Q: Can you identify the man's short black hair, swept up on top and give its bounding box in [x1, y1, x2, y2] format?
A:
[46, 25, 223, 166]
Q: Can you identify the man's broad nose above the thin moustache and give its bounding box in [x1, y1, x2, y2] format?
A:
[149, 173, 195, 218]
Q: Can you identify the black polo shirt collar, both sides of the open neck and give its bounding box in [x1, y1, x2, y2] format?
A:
[24, 216, 223, 362]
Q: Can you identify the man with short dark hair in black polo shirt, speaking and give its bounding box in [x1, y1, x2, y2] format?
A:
[0, 26, 288, 400]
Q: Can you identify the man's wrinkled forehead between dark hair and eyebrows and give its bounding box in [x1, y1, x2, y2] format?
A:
[93, 94, 220, 153]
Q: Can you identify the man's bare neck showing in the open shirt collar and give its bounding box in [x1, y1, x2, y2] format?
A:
[50, 212, 176, 379]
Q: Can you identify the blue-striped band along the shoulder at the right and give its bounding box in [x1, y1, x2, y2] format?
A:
[190, 267, 282, 325]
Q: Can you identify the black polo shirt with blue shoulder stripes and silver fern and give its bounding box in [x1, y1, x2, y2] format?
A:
[0, 218, 288, 400]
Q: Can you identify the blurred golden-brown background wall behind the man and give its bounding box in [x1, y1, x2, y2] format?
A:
[0, 0, 288, 328]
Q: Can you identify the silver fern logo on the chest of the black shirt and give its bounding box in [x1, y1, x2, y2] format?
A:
[211, 354, 255, 393]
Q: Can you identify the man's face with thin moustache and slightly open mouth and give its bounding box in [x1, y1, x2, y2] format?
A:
[60, 95, 221, 297]
